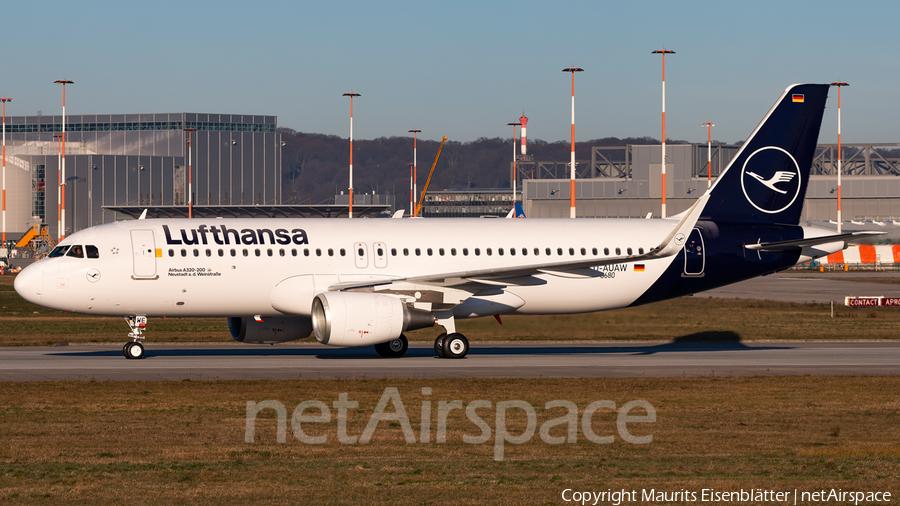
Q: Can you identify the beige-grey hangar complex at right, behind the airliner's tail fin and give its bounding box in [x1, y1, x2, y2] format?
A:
[423, 144, 900, 223]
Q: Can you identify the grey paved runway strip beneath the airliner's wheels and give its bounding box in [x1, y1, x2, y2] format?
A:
[0, 342, 900, 381]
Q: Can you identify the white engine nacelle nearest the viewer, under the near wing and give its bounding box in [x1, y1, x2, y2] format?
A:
[312, 292, 434, 346]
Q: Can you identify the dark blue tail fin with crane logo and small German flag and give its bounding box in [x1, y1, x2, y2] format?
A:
[700, 84, 829, 225]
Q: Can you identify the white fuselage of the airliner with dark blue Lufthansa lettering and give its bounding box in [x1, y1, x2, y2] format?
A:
[17, 215, 677, 318]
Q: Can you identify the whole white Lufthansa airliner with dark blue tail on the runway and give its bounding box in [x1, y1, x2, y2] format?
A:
[15, 85, 876, 358]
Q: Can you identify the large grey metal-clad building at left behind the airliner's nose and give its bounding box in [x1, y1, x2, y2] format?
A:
[6, 113, 282, 237]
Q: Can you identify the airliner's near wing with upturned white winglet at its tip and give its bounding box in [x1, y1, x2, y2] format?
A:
[329, 194, 708, 290]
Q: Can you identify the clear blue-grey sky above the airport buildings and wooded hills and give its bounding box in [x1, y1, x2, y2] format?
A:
[0, 0, 900, 143]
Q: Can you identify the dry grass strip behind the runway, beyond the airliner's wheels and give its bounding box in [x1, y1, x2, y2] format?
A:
[0, 276, 900, 346]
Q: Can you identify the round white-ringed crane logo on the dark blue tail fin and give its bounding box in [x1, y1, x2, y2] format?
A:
[741, 146, 801, 214]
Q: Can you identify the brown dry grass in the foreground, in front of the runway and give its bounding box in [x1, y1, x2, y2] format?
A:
[0, 377, 900, 504]
